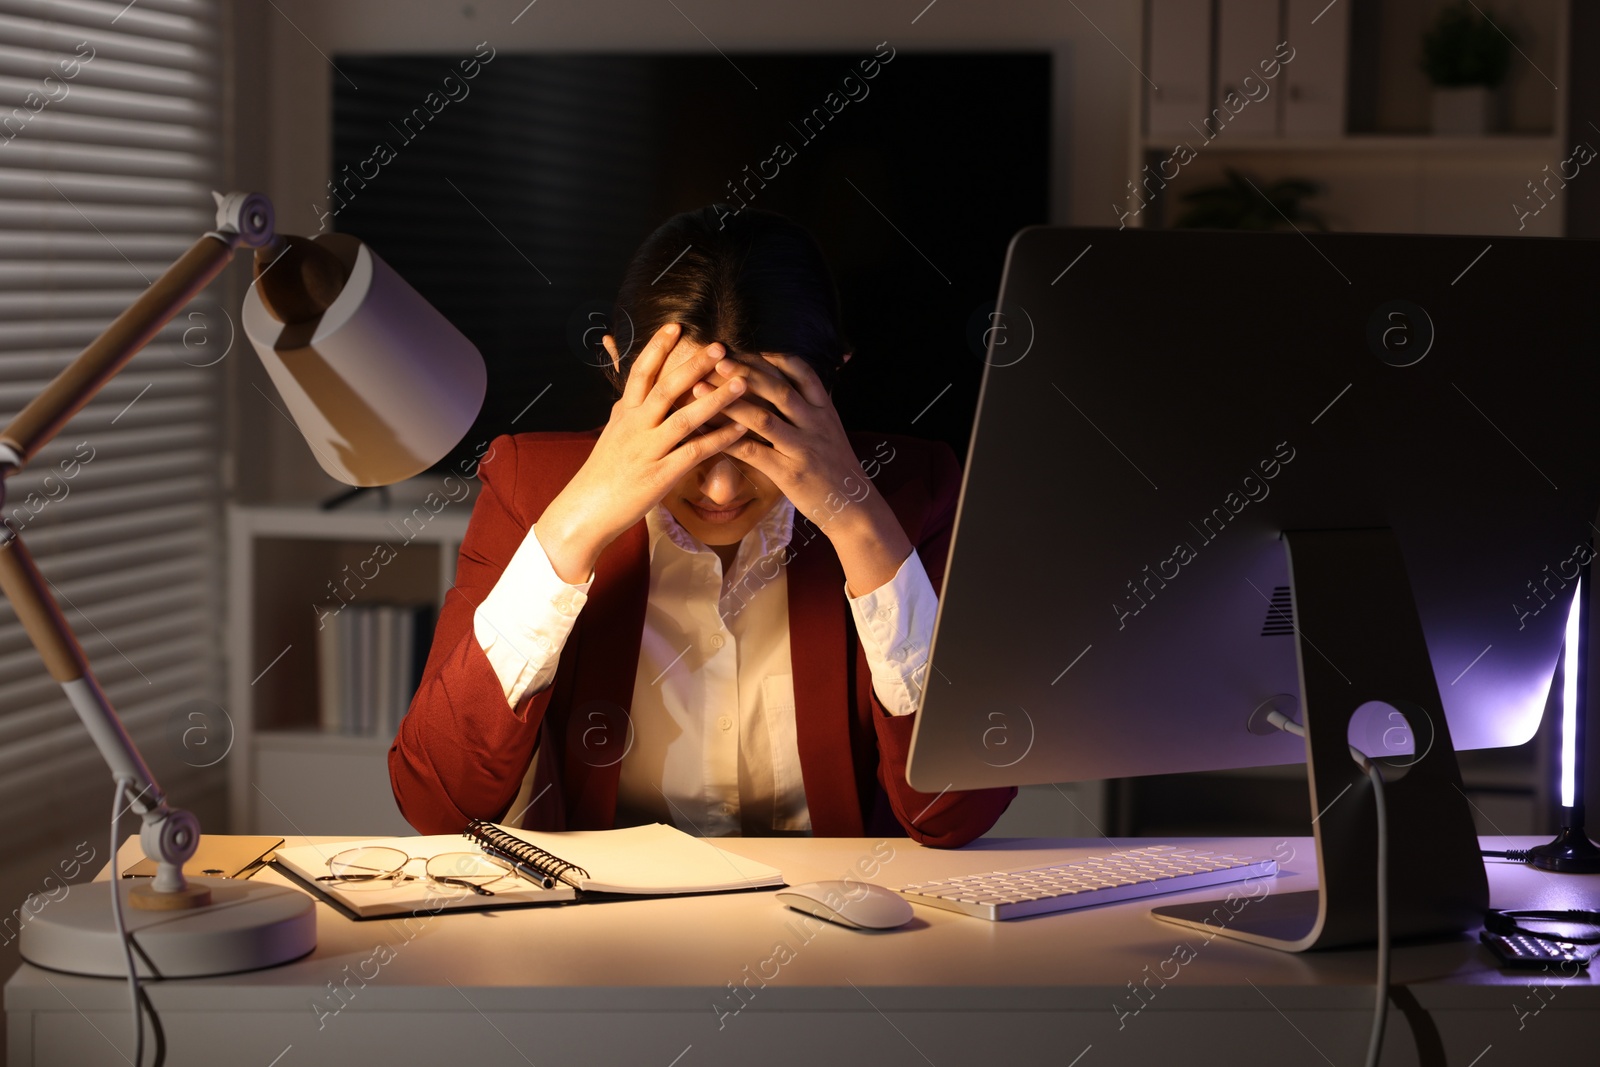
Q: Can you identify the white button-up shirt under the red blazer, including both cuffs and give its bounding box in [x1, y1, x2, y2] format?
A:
[474, 499, 938, 837]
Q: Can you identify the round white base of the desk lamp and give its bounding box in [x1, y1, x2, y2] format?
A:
[19, 878, 317, 977]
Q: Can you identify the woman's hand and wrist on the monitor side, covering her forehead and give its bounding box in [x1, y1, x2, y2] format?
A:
[694, 352, 912, 597]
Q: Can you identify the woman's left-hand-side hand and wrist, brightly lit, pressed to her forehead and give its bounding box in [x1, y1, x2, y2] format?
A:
[538, 323, 747, 584]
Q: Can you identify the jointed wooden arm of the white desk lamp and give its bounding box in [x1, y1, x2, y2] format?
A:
[0, 194, 272, 896]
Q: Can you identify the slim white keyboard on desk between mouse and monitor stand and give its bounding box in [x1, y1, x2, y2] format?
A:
[896, 845, 1278, 920]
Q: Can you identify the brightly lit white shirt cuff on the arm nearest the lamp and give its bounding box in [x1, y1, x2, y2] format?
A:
[472, 525, 594, 707]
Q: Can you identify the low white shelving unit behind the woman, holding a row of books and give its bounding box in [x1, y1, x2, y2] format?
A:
[227, 495, 475, 835]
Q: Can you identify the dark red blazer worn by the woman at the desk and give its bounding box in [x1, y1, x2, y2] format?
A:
[389, 432, 1016, 848]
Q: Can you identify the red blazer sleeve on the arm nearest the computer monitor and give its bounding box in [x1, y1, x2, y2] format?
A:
[856, 442, 1016, 848]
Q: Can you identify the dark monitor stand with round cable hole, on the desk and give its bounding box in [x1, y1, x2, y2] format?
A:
[1152, 528, 1490, 952]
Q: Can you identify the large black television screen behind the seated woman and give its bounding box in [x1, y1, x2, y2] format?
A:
[328, 48, 1051, 469]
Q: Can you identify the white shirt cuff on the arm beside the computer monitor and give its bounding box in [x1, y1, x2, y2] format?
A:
[845, 549, 939, 715]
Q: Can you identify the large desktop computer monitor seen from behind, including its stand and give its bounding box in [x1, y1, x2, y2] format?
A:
[909, 227, 1600, 950]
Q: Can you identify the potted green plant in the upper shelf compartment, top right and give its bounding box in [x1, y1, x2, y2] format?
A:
[1422, 0, 1515, 136]
